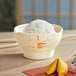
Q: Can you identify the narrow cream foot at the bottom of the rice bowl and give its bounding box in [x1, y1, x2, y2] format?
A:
[23, 50, 54, 59]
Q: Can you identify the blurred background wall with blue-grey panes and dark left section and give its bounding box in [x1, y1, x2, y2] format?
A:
[0, 0, 76, 31]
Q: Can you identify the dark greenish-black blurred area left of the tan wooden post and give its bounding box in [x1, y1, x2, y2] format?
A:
[0, 0, 16, 31]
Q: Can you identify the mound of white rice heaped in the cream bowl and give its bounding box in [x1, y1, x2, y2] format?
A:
[24, 19, 56, 34]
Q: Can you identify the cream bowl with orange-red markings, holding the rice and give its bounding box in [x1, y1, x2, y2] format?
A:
[14, 24, 63, 59]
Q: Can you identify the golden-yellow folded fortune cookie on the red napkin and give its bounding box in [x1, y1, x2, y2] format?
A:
[46, 58, 68, 76]
